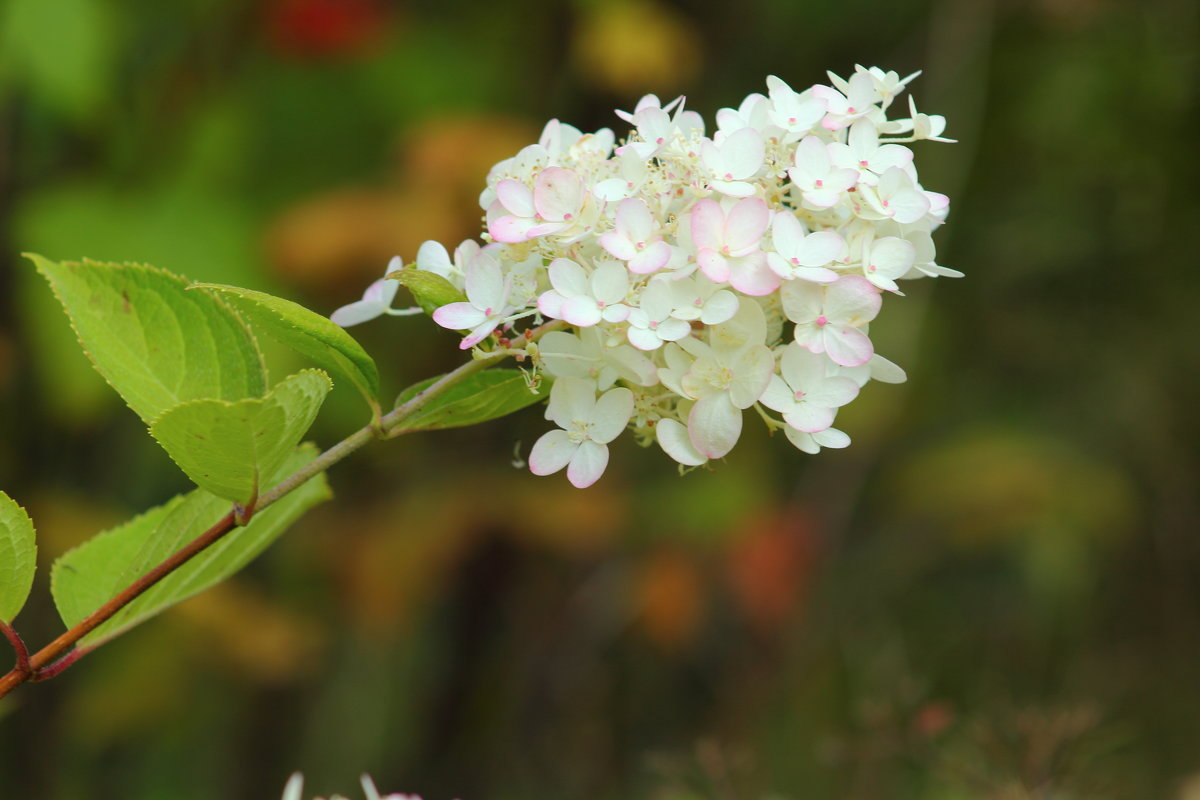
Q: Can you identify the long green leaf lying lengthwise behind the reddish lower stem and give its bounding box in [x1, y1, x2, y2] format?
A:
[50, 444, 331, 645]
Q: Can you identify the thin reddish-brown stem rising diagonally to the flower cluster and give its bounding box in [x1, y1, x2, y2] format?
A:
[0, 320, 563, 697]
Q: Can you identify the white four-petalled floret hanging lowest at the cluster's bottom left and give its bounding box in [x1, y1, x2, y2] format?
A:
[529, 378, 634, 489]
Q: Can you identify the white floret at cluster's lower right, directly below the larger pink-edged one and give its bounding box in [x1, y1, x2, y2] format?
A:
[761, 342, 858, 433]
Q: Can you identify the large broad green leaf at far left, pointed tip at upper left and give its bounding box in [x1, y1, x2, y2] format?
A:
[29, 255, 266, 423]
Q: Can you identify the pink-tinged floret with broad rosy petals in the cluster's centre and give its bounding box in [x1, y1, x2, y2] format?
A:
[690, 198, 779, 295]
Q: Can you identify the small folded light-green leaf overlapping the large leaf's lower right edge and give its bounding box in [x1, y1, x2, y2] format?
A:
[150, 369, 332, 504]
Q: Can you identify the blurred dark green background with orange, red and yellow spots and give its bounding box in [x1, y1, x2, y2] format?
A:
[0, 0, 1200, 800]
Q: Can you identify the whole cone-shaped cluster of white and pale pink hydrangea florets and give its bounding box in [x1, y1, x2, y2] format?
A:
[335, 67, 961, 487]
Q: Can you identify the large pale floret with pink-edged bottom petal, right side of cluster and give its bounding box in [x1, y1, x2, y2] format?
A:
[782, 275, 883, 367]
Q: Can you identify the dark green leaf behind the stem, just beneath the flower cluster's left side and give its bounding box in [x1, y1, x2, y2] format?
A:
[394, 368, 550, 433]
